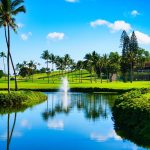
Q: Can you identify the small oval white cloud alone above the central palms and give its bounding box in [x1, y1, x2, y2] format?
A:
[47, 32, 65, 40]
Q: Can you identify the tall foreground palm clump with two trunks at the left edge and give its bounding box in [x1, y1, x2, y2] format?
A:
[0, 0, 26, 93]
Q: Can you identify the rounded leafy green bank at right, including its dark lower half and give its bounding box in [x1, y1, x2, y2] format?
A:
[113, 90, 150, 148]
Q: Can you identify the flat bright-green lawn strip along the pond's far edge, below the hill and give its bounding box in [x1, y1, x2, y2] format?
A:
[0, 80, 150, 92]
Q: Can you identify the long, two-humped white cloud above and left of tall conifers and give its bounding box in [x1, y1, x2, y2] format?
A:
[90, 19, 132, 32]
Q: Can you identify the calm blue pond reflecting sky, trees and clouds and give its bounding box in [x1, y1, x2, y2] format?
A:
[0, 92, 148, 150]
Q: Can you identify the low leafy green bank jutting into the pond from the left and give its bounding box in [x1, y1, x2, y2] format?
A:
[0, 91, 47, 114]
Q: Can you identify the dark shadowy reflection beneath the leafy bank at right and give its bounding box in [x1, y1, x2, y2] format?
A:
[113, 105, 150, 148]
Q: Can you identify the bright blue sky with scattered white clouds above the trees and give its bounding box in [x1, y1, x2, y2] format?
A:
[0, 0, 150, 68]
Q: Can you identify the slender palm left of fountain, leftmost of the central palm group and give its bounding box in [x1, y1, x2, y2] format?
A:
[41, 50, 50, 83]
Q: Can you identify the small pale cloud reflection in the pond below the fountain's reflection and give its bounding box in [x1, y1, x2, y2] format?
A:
[47, 120, 64, 130]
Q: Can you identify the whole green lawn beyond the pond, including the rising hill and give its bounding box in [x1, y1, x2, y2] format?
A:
[0, 70, 150, 90]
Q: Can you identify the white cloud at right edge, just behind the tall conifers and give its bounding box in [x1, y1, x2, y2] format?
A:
[135, 31, 150, 45]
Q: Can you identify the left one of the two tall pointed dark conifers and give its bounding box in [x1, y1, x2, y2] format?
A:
[120, 30, 130, 82]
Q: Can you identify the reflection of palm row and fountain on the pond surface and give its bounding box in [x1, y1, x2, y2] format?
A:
[42, 93, 114, 121]
